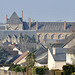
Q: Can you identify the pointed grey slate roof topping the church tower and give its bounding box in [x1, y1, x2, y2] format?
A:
[6, 12, 22, 24]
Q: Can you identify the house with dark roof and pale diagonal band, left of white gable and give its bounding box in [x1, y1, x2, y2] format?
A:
[34, 46, 48, 67]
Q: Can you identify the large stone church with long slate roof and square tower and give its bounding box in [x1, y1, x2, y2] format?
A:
[0, 11, 75, 44]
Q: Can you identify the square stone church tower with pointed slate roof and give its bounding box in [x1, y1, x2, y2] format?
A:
[5, 12, 23, 30]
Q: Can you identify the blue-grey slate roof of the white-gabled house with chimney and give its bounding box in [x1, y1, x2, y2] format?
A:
[49, 48, 66, 61]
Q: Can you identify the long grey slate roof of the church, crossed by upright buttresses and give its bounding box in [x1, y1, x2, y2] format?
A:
[25, 22, 75, 32]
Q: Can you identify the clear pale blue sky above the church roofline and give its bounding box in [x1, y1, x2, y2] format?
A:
[0, 0, 75, 23]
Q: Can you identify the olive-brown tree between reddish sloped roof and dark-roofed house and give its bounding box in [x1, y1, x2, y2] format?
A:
[26, 52, 35, 67]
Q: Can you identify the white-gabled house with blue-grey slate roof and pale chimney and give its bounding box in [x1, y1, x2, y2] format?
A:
[48, 48, 66, 70]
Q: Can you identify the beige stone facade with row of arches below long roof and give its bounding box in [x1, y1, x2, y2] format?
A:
[37, 32, 72, 44]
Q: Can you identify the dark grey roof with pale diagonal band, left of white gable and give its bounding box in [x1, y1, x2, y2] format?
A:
[34, 47, 48, 64]
